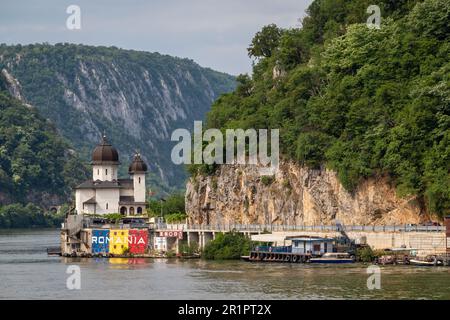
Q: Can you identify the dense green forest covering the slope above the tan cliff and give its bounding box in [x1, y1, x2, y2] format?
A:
[191, 0, 450, 216]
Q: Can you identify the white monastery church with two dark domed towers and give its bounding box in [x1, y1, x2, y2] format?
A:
[75, 136, 147, 216]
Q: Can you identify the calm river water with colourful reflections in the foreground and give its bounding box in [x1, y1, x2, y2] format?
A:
[0, 230, 450, 300]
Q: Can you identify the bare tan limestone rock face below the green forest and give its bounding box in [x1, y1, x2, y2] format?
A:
[186, 162, 429, 225]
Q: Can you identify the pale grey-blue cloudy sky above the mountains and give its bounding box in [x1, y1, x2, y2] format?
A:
[0, 0, 312, 75]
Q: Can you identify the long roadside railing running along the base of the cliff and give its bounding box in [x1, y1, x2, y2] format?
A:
[155, 223, 445, 233]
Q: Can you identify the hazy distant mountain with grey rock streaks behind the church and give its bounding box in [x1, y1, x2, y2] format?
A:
[0, 44, 235, 195]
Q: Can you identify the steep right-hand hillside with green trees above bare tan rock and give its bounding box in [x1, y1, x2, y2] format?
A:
[186, 0, 450, 223]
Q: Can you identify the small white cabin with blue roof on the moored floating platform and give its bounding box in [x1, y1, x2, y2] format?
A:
[286, 236, 334, 256]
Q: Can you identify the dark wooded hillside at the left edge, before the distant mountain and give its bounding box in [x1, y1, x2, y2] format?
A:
[0, 75, 87, 208]
